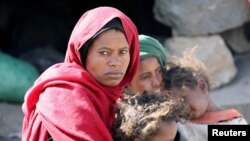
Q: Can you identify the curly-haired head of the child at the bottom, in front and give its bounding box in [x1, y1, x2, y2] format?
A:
[113, 92, 188, 141]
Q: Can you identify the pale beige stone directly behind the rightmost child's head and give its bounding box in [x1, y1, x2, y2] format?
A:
[164, 35, 237, 89]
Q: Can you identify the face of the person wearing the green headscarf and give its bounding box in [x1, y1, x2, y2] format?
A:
[128, 57, 163, 93]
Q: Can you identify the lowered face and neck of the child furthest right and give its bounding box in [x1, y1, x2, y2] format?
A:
[173, 85, 209, 119]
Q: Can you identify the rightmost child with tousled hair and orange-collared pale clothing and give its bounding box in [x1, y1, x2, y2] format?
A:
[164, 48, 247, 141]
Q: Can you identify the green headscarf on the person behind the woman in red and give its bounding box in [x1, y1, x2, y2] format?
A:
[139, 35, 167, 69]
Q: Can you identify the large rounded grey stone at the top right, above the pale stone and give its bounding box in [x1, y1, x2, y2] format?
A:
[153, 0, 250, 36]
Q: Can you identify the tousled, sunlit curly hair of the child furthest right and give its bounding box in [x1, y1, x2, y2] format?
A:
[163, 47, 210, 91]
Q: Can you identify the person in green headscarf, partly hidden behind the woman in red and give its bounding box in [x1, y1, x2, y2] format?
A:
[126, 35, 167, 94]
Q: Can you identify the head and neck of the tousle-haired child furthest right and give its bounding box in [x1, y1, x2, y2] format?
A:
[164, 49, 212, 119]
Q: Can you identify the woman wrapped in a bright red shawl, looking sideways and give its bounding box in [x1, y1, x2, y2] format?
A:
[22, 7, 139, 141]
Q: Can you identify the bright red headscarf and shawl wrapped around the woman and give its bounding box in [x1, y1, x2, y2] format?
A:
[22, 7, 139, 141]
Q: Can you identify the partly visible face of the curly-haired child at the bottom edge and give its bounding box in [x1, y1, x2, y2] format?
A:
[150, 120, 177, 141]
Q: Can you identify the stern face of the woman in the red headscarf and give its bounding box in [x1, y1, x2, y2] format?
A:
[86, 29, 130, 86]
